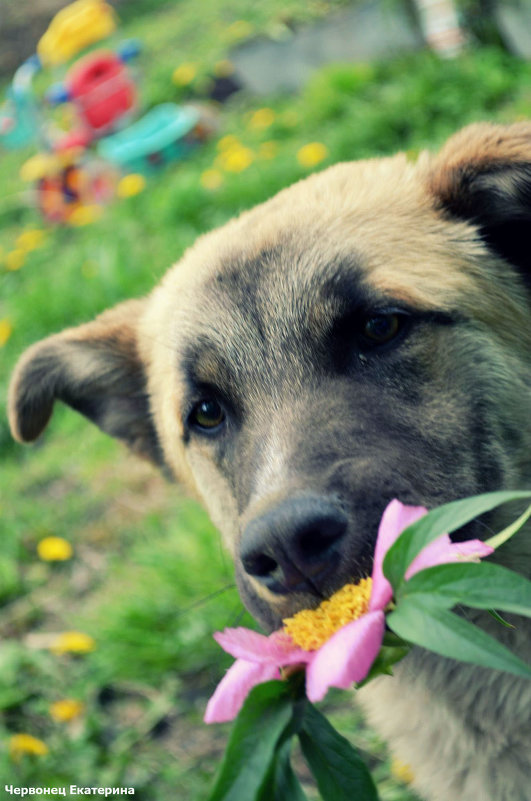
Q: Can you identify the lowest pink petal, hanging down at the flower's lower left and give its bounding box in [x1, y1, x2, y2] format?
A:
[204, 659, 280, 723]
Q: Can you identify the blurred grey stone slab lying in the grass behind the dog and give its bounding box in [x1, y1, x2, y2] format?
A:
[230, 0, 424, 94]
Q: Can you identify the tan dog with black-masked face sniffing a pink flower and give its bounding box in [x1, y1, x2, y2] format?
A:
[9, 122, 531, 801]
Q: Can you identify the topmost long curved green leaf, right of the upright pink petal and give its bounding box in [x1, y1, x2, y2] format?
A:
[383, 491, 531, 592]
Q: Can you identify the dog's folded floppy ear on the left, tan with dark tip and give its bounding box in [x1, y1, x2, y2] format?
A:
[8, 300, 161, 463]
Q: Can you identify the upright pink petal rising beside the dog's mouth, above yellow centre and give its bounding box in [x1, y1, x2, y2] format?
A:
[369, 498, 428, 612]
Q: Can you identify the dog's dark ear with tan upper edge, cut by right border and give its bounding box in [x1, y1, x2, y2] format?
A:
[430, 122, 531, 280]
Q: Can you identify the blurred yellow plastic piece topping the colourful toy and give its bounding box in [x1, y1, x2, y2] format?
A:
[37, 0, 116, 66]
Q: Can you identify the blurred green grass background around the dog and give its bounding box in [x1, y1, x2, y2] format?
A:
[0, 0, 531, 801]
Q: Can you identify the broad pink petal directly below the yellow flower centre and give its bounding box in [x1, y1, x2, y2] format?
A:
[306, 611, 385, 702]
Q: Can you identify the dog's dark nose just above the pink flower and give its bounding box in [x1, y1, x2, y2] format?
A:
[240, 495, 348, 595]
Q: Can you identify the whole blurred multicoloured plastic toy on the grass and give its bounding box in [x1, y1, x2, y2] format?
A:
[0, 0, 215, 224]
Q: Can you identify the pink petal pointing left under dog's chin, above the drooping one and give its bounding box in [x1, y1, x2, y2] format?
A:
[214, 626, 308, 666]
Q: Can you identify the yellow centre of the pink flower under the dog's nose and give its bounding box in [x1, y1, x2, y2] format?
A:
[283, 578, 372, 651]
